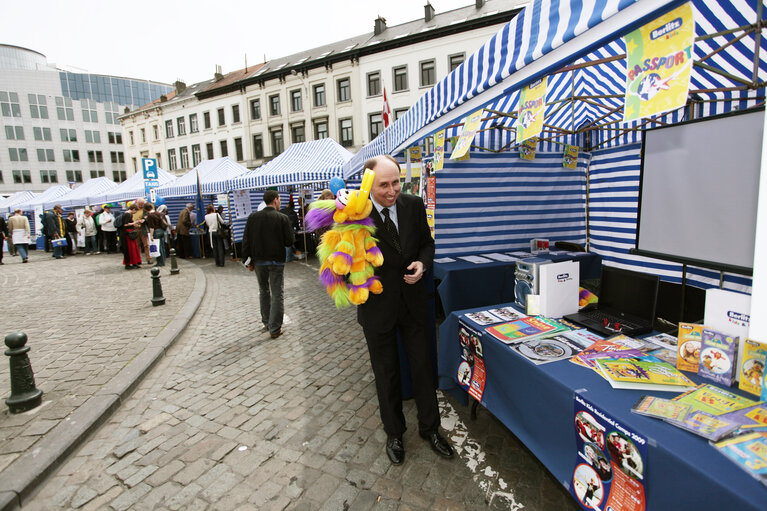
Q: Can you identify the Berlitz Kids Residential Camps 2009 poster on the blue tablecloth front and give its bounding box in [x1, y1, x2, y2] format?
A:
[570, 394, 647, 511]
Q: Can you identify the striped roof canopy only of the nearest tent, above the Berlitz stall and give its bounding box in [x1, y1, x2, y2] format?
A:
[344, 0, 767, 176]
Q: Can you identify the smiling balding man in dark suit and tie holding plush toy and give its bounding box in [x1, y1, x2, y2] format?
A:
[357, 155, 453, 465]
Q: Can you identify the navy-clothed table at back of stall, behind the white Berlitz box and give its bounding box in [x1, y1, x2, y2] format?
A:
[434, 252, 602, 316]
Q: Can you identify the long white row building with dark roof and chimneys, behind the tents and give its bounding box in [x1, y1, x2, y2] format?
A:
[120, 0, 525, 174]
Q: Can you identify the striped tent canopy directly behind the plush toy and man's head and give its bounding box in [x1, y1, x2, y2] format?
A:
[232, 138, 353, 190]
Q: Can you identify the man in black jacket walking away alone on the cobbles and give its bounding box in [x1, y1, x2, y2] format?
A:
[242, 190, 295, 339]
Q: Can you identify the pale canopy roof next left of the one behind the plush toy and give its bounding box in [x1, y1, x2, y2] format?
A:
[157, 156, 248, 197]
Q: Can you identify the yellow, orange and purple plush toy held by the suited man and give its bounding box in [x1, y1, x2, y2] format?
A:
[306, 169, 383, 309]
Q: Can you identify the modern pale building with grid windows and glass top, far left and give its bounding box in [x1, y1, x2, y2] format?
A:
[0, 44, 172, 195]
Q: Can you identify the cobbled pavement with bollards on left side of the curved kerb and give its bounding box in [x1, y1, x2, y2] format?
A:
[0, 247, 199, 504]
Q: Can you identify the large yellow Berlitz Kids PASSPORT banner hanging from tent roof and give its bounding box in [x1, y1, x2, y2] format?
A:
[623, 3, 695, 122]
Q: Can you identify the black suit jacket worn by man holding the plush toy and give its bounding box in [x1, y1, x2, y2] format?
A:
[357, 193, 434, 332]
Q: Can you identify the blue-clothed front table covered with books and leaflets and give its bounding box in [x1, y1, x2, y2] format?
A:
[439, 303, 767, 511]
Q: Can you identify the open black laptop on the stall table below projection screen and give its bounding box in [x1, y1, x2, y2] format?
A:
[564, 266, 660, 337]
